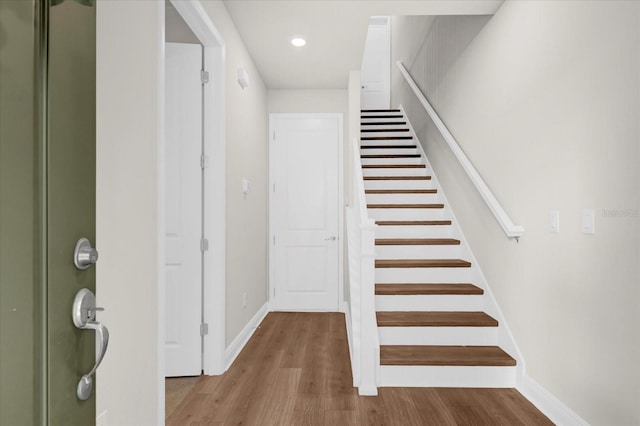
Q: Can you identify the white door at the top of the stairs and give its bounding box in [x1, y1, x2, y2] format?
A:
[360, 16, 391, 109]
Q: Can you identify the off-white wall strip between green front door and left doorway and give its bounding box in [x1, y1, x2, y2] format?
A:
[96, 1, 164, 426]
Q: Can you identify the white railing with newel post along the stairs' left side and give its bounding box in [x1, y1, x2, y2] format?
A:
[347, 139, 380, 395]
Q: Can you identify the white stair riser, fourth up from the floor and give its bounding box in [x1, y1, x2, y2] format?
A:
[375, 268, 471, 284]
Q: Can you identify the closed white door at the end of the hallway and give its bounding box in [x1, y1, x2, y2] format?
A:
[270, 114, 342, 311]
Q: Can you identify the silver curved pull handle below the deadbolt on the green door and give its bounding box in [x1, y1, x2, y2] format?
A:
[72, 288, 109, 401]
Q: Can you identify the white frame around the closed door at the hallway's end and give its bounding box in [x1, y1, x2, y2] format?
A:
[268, 113, 344, 311]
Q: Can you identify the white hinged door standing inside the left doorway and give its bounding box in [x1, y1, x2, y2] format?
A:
[165, 43, 202, 376]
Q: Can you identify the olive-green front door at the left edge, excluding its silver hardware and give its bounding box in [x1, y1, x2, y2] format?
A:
[0, 0, 99, 426]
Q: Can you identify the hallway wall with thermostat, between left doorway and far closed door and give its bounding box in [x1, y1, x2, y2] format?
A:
[202, 1, 269, 345]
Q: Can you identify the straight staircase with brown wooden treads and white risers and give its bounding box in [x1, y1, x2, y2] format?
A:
[360, 109, 517, 387]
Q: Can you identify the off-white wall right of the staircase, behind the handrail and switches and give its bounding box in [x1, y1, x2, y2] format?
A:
[393, 1, 640, 425]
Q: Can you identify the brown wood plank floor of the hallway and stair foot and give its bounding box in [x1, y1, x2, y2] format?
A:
[166, 312, 553, 426]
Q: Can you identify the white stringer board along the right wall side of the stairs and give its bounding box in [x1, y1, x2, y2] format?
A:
[398, 105, 526, 387]
